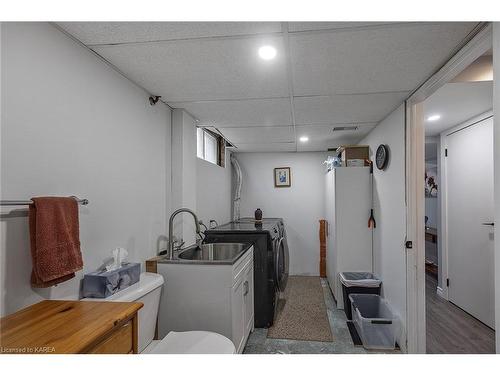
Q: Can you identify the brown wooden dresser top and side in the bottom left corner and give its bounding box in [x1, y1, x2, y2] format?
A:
[0, 300, 143, 354]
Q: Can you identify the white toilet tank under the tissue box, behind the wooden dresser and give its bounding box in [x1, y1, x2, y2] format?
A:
[83, 272, 163, 353]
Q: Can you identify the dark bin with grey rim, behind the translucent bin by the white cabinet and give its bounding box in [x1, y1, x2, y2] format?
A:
[339, 272, 382, 320]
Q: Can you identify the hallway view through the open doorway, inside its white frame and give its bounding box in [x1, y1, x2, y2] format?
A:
[423, 85, 495, 354]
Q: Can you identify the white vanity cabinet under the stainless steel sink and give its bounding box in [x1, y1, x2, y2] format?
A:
[155, 247, 254, 353]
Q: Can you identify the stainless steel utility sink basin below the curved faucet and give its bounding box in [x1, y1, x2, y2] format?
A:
[177, 243, 251, 263]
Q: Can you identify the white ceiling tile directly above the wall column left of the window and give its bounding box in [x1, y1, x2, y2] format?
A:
[169, 98, 292, 128]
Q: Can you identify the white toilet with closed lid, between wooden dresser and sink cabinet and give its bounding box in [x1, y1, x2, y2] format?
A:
[84, 272, 236, 354]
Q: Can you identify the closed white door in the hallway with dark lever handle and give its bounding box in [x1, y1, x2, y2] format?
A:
[446, 118, 495, 328]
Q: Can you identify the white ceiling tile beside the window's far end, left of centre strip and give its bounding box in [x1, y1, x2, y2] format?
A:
[219, 126, 295, 146]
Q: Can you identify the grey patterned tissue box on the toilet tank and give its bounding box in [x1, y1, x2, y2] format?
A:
[82, 263, 141, 298]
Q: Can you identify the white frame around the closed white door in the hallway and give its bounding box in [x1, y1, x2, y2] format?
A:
[438, 109, 493, 300]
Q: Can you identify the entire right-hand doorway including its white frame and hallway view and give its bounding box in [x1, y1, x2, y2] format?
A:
[406, 25, 495, 353]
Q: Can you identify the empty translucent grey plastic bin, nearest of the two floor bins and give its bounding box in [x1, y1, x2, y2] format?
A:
[349, 294, 398, 350]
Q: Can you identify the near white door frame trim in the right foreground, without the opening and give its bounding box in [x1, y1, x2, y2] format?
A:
[405, 23, 493, 353]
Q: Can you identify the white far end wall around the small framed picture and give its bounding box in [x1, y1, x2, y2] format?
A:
[236, 152, 327, 275]
